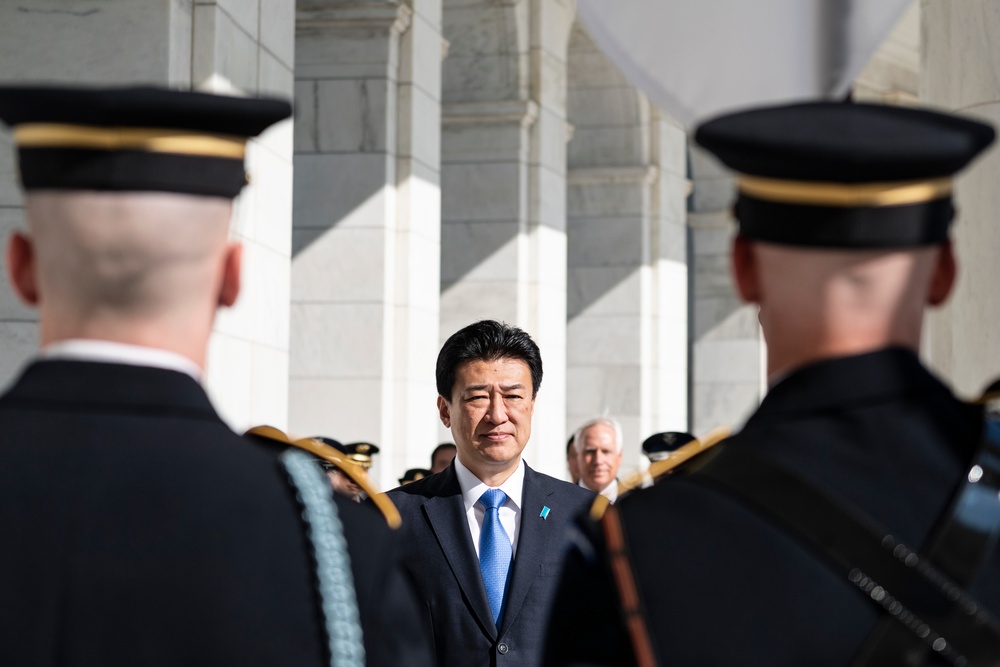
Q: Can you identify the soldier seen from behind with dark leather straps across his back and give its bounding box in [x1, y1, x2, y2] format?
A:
[545, 103, 1000, 666]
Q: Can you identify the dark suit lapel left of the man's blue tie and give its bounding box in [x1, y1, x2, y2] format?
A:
[423, 465, 500, 639]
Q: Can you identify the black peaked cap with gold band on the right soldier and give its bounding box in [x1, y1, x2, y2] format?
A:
[695, 102, 994, 248]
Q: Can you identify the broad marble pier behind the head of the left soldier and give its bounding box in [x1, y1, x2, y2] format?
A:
[0, 0, 294, 430]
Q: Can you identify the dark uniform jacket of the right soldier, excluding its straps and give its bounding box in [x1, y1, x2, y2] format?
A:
[546, 349, 1000, 665]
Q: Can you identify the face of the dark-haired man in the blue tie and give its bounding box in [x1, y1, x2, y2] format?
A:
[438, 359, 535, 478]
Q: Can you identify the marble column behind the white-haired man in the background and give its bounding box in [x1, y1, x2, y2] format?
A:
[567, 23, 688, 471]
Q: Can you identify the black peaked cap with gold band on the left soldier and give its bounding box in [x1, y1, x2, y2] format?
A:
[0, 86, 291, 198]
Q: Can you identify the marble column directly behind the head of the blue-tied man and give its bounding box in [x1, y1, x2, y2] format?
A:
[440, 0, 574, 474]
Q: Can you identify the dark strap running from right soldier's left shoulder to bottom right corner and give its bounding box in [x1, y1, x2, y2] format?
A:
[679, 438, 1000, 665]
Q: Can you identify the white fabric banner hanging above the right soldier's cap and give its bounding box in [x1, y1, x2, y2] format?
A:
[578, 0, 911, 127]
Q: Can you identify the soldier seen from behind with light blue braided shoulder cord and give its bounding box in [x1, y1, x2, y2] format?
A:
[0, 88, 430, 667]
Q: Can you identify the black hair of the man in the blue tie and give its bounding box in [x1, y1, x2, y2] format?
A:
[434, 320, 542, 401]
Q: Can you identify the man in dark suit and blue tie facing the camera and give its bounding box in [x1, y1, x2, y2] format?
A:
[389, 321, 593, 667]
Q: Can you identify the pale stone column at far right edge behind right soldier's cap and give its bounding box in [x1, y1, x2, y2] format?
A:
[920, 0, 1000, 396]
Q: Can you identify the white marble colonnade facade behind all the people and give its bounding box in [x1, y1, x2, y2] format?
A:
[0, 0, 1000, 487]
